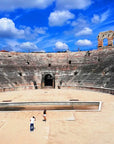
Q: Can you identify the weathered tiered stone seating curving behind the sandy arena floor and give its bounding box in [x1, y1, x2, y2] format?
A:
[0, 48, 114, 90]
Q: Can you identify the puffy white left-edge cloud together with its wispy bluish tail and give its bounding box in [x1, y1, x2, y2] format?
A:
[0, 18, 47, 40]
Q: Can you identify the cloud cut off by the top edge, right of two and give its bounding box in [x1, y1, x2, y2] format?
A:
[56, 0, 92, 10]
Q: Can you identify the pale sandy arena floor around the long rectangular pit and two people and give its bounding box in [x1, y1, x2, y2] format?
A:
[0, 89, 114, 144]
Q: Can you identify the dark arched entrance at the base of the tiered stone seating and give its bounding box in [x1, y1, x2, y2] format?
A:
[42, 74, 55, 88]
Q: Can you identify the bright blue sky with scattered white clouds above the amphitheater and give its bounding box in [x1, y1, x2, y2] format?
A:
[0, 0, 114, 52]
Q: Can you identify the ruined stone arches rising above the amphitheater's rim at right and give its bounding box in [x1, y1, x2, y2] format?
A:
[97, 31, 114, 48]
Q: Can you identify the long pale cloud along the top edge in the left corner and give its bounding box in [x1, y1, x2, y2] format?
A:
[0, 0, 54, 11]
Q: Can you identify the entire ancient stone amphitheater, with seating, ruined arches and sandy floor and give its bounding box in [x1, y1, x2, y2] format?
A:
[0, 31, 114, 144]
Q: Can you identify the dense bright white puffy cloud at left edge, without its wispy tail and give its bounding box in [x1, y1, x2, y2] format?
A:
[0, 18, 24, 38]
